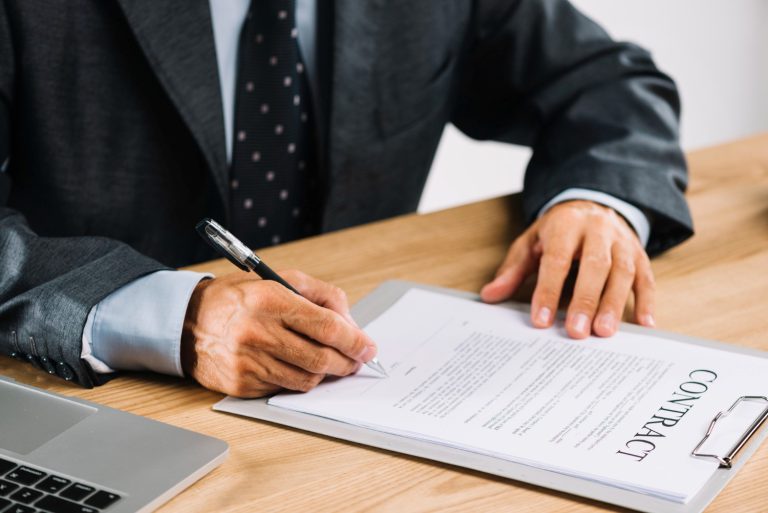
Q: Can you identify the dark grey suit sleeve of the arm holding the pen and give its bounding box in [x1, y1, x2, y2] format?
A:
[0, 3, 164, 387]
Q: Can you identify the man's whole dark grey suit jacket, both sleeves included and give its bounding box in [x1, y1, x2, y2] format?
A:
[0, 0, 692, 386]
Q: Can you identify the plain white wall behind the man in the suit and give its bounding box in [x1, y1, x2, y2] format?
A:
[419, 0, 768, 212]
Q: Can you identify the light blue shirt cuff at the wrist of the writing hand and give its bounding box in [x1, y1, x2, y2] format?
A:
[81, 271, 212, 377]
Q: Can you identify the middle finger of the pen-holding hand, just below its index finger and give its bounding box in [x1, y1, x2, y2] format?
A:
[268, 329, 359, 376]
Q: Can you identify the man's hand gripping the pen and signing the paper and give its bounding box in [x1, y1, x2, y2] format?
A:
[181, 271, 377, 398]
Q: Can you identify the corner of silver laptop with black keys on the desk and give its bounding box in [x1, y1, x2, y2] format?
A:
[0, 377, 229, 513]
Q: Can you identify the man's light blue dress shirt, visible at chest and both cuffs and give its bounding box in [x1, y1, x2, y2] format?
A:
[82, 0, 650, 376]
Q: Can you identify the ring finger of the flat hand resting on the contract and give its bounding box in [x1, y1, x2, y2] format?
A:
[594, 244, 637, 337]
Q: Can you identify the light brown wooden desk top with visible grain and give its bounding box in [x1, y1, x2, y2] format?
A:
[0, 134, 768, 513]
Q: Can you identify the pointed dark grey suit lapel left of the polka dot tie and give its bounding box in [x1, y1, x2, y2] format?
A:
[117, 0, 229, 209]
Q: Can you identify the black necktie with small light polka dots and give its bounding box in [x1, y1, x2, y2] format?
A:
[230, 0, 317, 248]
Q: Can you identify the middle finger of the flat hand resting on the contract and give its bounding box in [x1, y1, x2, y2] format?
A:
[565, 231, 611, 338]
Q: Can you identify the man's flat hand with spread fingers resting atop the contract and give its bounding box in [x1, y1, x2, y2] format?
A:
[481, 200, 655, 338]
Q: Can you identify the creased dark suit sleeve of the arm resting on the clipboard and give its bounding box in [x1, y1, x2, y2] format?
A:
[452, 0, 693, 254]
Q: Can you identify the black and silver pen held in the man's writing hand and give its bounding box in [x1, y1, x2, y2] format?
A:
[195, 218, 389, 376]
